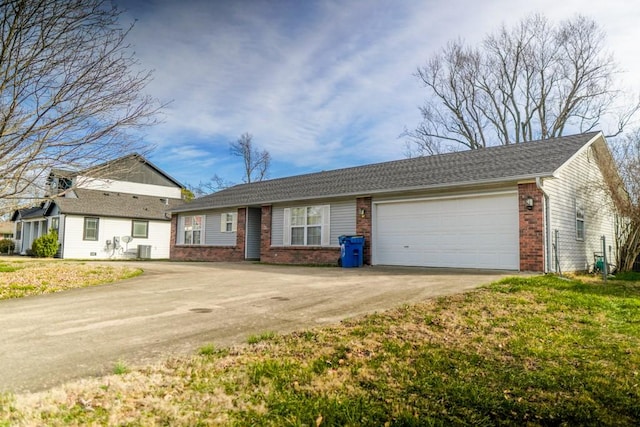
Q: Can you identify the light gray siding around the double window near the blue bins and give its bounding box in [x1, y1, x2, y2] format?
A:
[271, 199, 356, 246]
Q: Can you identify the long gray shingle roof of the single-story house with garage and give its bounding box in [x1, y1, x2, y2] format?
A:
[171, 132, 599, 212]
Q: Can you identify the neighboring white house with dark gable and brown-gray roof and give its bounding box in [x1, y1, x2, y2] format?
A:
[12, 154, 182, 259]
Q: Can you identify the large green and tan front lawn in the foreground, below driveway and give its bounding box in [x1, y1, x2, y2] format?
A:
[0, 276, 640, 426]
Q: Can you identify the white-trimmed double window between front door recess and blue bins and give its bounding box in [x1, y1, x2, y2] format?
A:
[284, 205, 330, 246]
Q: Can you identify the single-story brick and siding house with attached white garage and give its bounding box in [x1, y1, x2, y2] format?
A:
[171, 132, 618, 272]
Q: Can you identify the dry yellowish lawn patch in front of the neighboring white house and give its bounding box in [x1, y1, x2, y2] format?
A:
[0, 258, 142, 300]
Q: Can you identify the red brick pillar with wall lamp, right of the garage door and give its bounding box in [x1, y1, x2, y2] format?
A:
[518, 183, 544, 272]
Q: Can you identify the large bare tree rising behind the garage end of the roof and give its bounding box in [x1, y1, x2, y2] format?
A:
[405, 15, 639, 154]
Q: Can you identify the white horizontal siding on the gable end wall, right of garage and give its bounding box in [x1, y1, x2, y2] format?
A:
[543, 148, 615, 271]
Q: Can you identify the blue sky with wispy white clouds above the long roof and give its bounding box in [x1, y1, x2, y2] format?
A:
[116, 0, 640, 185]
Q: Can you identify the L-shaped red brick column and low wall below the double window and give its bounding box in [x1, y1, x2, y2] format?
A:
[260, 206, 340, 265]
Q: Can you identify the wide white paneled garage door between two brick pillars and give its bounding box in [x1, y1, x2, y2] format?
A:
[373, 193, 520, 270]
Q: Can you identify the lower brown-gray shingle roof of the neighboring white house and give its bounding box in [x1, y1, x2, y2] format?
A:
[54, 189, 182, 220]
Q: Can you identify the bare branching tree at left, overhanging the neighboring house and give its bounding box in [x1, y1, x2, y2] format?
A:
[0, 0, 160, 214]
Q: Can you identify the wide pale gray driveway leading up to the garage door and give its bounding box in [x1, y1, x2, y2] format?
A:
[0, 262, 513, 392]
